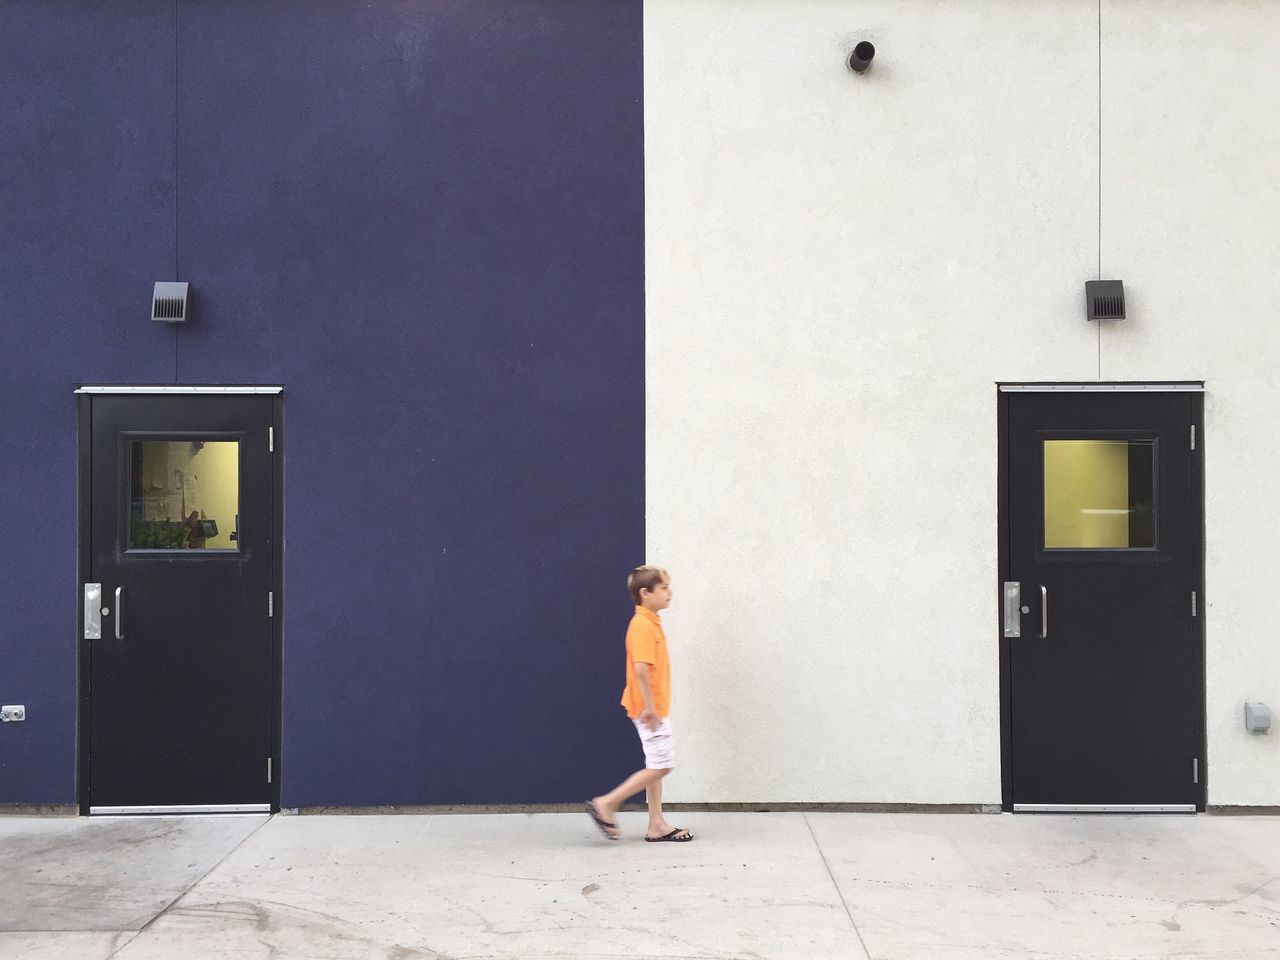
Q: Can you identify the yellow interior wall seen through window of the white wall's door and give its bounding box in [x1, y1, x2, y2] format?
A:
[1044, 440, 1129, 549]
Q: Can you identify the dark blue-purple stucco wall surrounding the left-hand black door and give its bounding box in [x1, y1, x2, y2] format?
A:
[0, 0, 644, 806]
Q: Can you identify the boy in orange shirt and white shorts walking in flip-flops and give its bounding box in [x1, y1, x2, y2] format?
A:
[586, 566, 694, 844]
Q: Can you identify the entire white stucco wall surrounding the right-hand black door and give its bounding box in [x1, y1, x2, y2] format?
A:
[645, 0, 1280, 804]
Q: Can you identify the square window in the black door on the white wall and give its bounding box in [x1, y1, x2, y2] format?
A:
[1044, 439, 1156, 550]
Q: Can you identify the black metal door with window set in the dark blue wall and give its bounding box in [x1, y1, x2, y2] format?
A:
[81, 396, 276, 813]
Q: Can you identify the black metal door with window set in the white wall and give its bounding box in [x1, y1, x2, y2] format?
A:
[1001, 390, 1206, 810]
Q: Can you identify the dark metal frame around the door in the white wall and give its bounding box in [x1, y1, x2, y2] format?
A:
[993, 380, 1210, 813]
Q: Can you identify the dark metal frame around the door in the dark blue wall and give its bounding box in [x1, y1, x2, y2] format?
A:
[76, 384, 284, 817]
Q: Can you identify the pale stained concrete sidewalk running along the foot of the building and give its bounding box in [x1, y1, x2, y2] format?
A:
[0, 813, 1280, 960]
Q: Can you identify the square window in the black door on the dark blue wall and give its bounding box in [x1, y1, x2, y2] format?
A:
[129, 439, 239, 550]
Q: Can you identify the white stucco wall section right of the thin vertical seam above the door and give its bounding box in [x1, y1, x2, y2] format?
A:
[1102, 0, 1280, 804]
